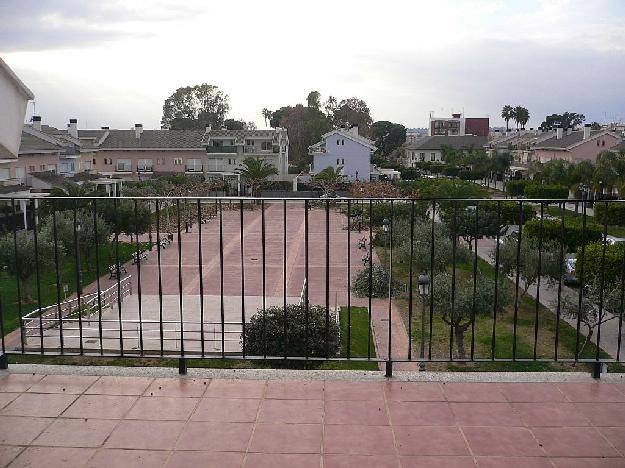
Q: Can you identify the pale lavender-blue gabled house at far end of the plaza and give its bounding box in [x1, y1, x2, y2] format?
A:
[308, 126, 376, 181]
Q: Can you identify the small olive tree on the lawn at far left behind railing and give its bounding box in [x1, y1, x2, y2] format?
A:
[0, 231, 54, 302]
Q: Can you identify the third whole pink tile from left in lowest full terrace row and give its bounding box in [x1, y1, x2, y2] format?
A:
[176, 421, 253, 452]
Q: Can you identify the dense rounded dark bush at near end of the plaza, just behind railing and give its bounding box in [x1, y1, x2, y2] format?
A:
[245, 304, 340, 357]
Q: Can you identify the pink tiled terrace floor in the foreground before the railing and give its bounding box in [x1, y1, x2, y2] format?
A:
[0, 366, 625, 468]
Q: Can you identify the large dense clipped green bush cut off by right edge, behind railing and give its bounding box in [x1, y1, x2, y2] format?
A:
[575, 242, 625, 287]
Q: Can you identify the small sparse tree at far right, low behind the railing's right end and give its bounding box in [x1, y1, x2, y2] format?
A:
[561, 280, 623, 356]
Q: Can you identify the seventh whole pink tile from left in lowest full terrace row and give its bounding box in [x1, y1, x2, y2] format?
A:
[463, 427, 545, 457]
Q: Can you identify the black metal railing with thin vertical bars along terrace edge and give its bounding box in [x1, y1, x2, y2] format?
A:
[0, 197, 625, 375]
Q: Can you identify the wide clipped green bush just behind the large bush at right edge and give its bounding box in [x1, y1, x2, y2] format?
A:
[525, 218, 603, 252]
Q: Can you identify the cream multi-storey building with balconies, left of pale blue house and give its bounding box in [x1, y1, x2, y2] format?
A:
[202, 127, 289, 180]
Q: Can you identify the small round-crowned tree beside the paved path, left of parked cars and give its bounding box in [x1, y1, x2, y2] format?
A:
[498, 235, 560, 297]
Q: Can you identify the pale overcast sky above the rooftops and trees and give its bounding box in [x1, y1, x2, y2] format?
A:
[0, 0, 625, 128]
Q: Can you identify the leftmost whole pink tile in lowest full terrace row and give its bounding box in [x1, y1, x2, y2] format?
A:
[34, 418, 117, 447]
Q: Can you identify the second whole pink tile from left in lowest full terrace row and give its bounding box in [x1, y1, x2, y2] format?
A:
[106, 421, 184, 450]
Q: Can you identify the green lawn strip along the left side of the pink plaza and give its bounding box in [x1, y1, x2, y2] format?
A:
[0, 242, 149, 334]
